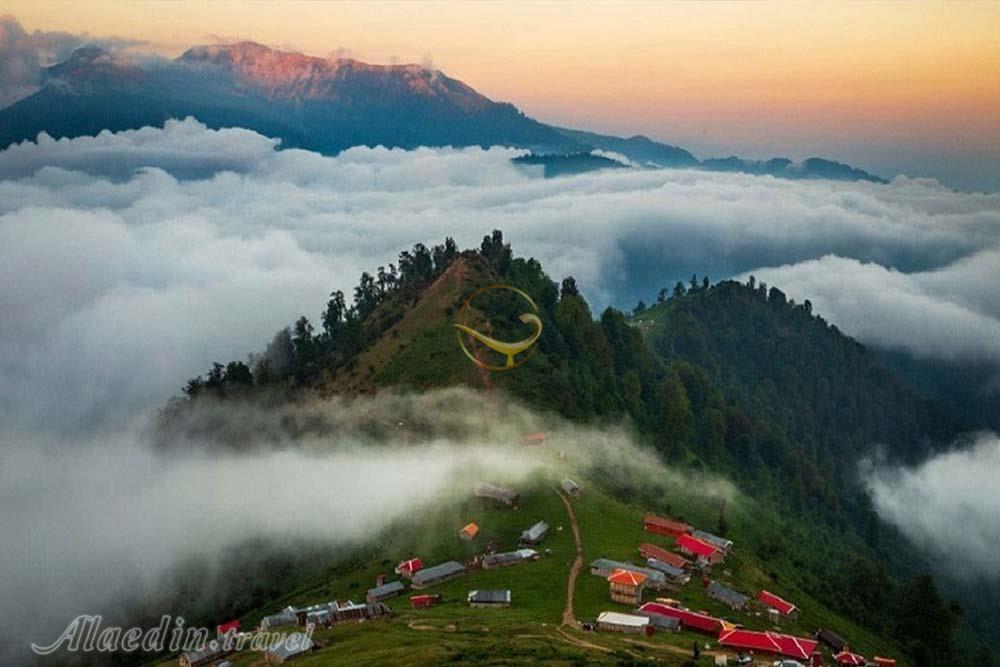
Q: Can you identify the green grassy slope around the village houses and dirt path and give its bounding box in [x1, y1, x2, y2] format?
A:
[152, 475, 899, 666]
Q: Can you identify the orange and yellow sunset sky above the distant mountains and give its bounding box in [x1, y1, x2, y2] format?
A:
[0, 0, 1000, 188]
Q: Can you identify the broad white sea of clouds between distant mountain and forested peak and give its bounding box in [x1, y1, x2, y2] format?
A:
[0, 120, 1000, 438]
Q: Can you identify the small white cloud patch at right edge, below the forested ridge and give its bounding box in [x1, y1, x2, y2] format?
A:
[865, 433, 1000, 580]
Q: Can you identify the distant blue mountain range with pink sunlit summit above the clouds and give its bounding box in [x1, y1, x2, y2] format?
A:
[0, 42, 882, 182]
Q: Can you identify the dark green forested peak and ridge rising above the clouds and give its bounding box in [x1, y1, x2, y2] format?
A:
[170, 231, 991, 666]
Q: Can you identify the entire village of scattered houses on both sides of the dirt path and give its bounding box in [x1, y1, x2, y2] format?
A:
[178, 444, 908, 667]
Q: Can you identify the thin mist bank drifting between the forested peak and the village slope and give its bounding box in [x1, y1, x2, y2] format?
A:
[0, 389, 738, 660]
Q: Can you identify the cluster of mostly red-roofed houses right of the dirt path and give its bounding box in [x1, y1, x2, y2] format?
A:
[590, 514, 895, 667]
